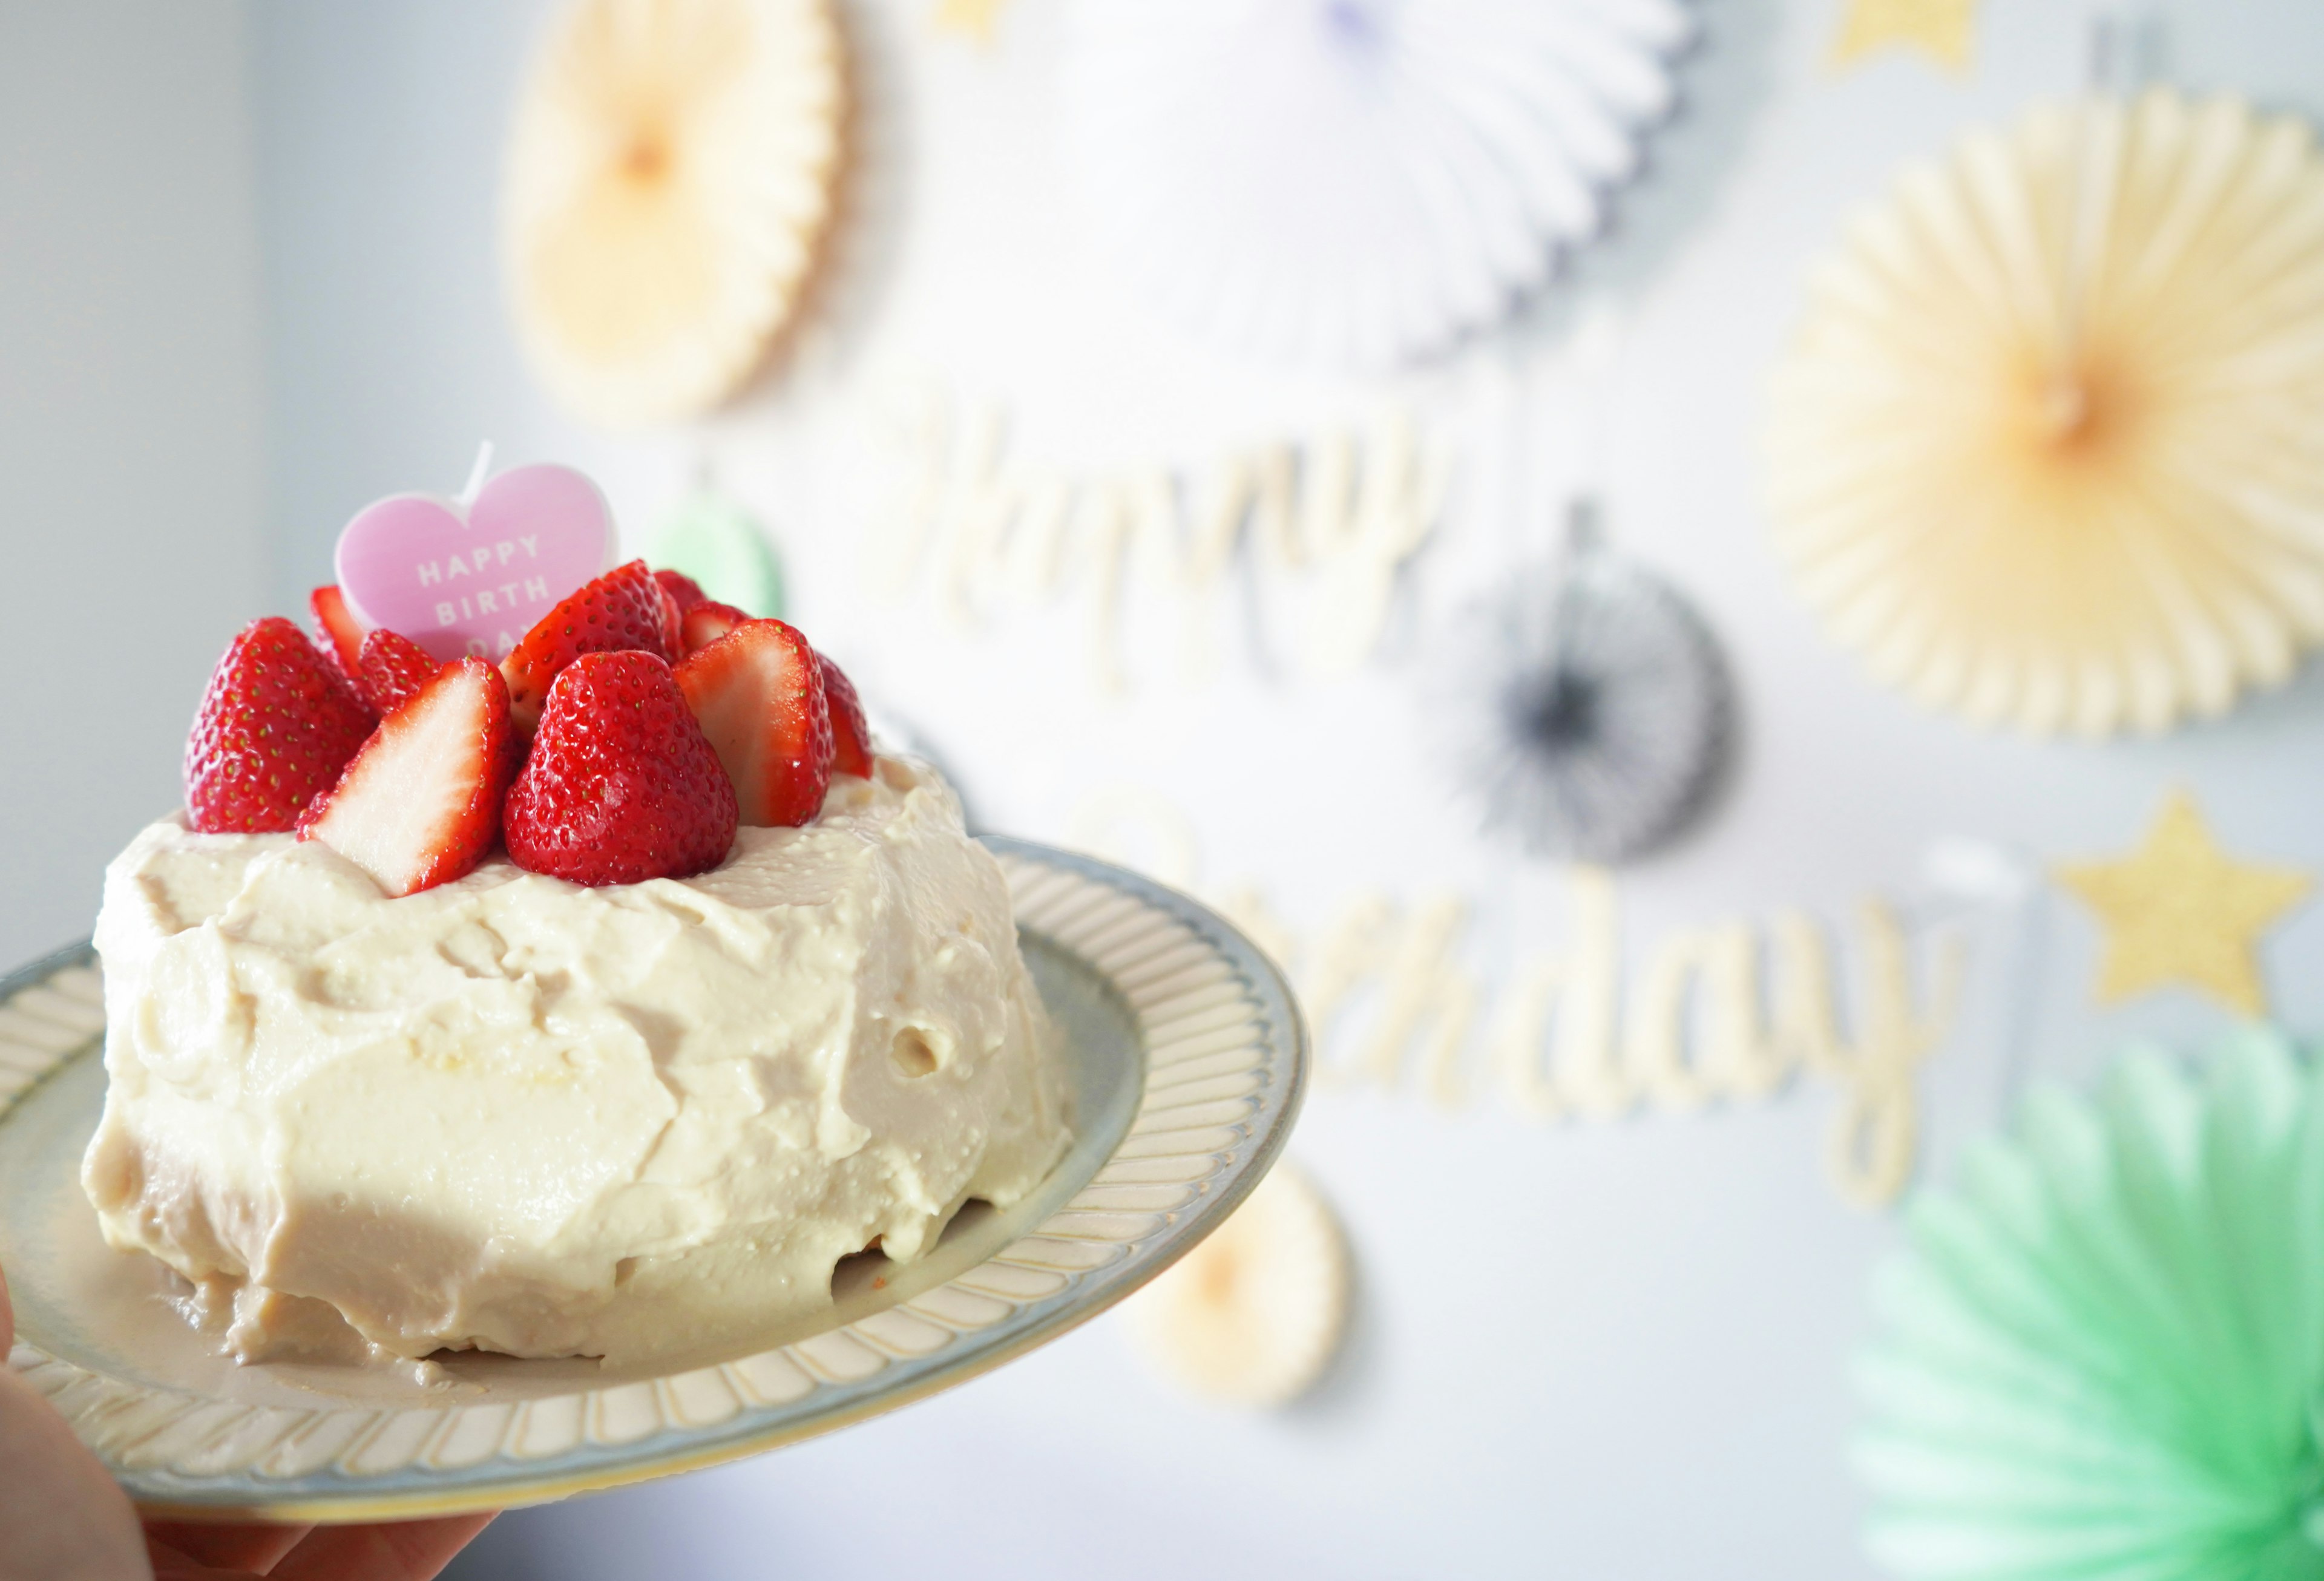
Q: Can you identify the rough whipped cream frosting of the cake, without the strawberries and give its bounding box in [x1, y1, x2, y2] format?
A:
[81, 758, 1069, 1360]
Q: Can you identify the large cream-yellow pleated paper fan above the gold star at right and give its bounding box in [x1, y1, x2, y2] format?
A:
[1771, 88, 2324, 737]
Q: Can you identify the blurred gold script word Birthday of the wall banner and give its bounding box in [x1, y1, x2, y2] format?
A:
[1076, 793, 1966, 1206]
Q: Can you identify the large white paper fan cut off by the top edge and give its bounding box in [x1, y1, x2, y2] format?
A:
[1065, 0, 1694, 367]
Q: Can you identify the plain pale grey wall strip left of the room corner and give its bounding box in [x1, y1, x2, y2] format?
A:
[0, 0, 265, 963]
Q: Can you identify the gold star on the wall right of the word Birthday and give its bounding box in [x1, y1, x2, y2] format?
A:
[2056, 791, 2313, 1016]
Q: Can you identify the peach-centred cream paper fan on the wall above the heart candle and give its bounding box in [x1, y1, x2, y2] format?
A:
[502, 0, 846, 423]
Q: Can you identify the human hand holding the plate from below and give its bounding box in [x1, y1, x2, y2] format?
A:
[0, 1277, 493, 1581]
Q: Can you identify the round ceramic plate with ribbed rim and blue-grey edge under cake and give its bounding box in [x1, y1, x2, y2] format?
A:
[0, 839, 1306, 1520]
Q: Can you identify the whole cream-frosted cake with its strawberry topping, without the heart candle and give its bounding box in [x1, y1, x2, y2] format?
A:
[81, 563, 1069, 1360]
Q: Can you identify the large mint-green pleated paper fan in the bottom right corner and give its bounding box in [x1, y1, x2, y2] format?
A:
[1857, 1030, 2324, 1581]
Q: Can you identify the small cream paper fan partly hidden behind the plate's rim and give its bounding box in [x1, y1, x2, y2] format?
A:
[1129, 1162, 1348, 1407]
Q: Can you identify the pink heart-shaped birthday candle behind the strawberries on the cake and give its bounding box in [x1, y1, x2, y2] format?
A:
[337, 465, 614, 660]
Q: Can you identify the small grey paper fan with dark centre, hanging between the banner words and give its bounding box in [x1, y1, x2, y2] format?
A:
[1431, 539, 1734, 863]
